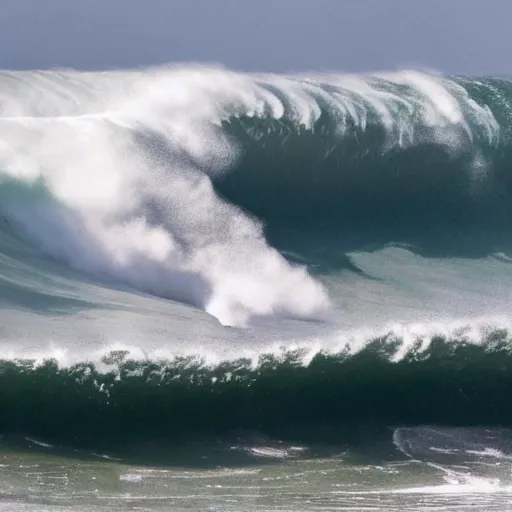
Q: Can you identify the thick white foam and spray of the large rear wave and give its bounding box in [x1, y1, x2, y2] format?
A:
[0, 66, 499, 325]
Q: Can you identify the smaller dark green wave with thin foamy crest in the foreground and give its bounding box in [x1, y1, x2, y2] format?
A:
[0, 329, 512, 449]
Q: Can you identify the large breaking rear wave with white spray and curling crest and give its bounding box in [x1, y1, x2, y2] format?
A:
[0, 66, 511, 325]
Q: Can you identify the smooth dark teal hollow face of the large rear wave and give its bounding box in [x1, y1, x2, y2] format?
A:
[214, 79, 512, 232]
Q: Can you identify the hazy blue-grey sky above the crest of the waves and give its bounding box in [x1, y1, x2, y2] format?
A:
[0, 0, 512, 75]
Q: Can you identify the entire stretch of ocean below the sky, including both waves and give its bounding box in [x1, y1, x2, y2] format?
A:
[0, 65, 512, 511]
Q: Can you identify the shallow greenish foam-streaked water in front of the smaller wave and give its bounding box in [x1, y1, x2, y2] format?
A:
[0, 429, 512, 511]
